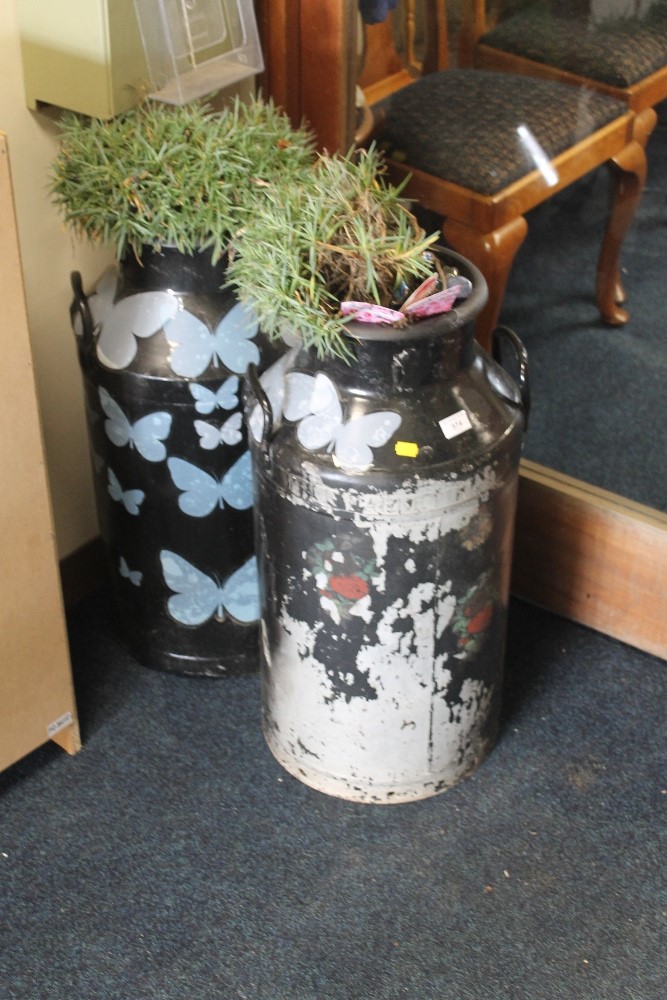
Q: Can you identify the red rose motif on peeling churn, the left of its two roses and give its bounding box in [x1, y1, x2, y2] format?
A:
[306, 536, 376, 624]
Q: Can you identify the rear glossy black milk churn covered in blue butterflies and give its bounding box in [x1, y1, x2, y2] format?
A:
[71, 249, 278, 677]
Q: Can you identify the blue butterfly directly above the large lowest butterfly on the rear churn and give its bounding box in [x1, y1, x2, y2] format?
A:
[167, 451, 253, 517]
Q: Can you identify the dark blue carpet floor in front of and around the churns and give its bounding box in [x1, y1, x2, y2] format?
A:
[0, 594, 667, 1000]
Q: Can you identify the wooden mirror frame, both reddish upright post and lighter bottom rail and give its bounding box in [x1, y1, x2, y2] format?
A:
[255, 0, 667, 659]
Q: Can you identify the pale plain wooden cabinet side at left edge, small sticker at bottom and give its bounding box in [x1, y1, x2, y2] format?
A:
[0, 133, 80, 770]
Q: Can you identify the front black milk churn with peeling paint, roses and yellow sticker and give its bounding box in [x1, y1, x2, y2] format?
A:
[247, 251, 528, 803]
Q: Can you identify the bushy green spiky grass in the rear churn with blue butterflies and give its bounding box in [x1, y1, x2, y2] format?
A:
[50, 98, 315, 260]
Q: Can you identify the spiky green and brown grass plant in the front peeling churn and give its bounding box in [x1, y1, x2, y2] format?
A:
[228, 148, 438, 359]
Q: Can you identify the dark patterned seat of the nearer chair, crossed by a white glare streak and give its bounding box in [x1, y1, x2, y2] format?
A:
[382, 69, 626, 195]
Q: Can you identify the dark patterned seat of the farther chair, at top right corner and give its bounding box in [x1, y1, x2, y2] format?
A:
[478, 6, 667, 88]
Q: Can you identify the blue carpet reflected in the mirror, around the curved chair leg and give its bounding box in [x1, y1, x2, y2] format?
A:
[500, 103, 667, 511]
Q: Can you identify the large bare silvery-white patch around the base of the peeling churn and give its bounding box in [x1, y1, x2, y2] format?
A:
[266, 556, 498, 801]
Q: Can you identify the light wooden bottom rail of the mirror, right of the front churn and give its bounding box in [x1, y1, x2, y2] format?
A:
[512, 460, 667, 659]
